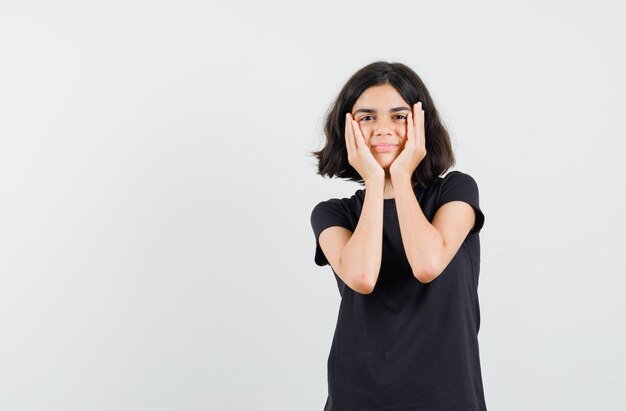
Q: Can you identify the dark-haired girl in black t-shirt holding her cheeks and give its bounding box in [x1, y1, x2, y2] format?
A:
[311, 62, 486, 411]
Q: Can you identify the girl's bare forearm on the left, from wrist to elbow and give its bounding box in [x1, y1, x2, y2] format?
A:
[341, 179, 385, 290]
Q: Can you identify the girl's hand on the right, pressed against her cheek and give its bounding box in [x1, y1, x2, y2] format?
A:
[389, 102, 426, 177]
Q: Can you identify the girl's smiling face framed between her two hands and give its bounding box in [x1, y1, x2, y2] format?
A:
[352, 84, 411, 169]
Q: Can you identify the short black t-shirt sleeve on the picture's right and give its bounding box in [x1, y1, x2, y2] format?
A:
[436, 170, 485, 234]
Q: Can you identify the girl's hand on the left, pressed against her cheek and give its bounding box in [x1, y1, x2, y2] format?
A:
[345, 113, 385, 181]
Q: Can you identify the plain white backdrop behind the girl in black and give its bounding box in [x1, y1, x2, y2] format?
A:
[0, 0, 626, 411]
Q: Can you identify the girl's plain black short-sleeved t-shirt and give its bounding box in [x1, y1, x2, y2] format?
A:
[311, 170, 487, 411]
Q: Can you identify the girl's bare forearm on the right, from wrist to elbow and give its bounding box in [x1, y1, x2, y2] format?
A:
[392, 175, 444, 283]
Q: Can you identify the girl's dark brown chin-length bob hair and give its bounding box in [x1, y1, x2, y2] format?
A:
[311, 61, 455, 188]
